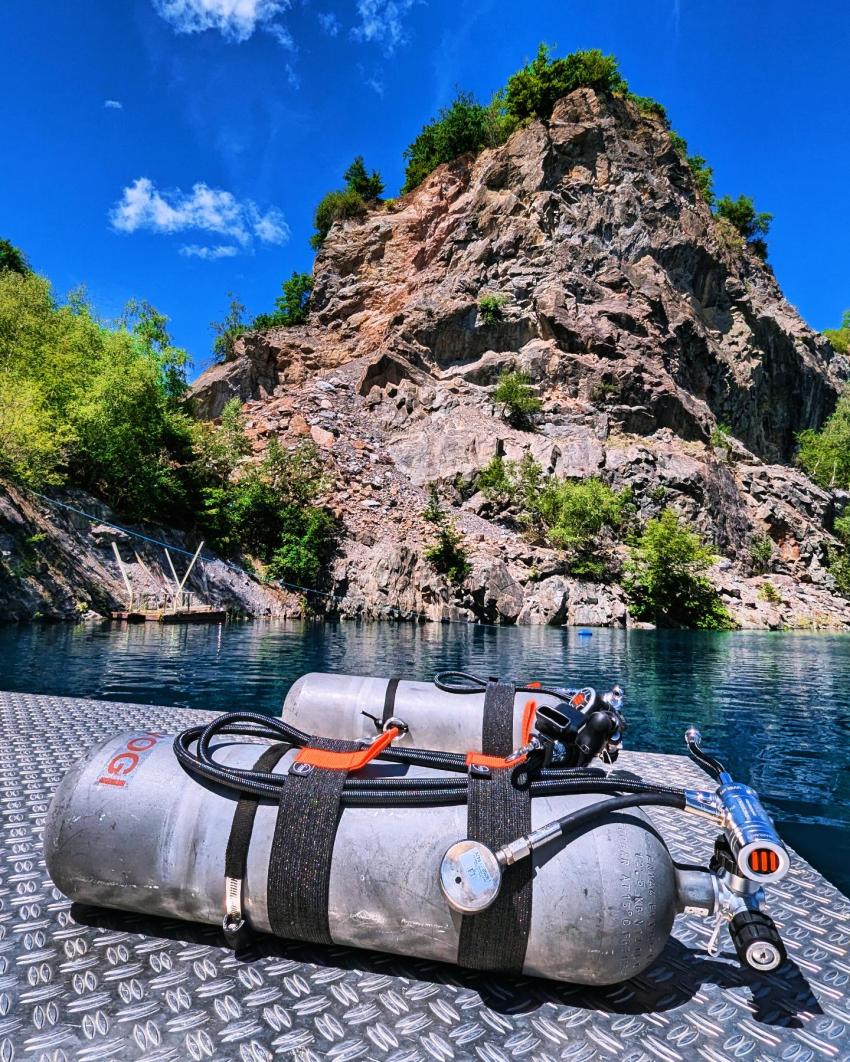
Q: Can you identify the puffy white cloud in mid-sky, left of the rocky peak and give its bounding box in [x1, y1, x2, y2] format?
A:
[109, 177, 289, 258]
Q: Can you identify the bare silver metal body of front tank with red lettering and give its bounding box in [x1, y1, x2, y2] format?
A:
[45, 732, 678, 984]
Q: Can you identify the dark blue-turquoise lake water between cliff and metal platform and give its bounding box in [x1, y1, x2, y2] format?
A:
[0, 622, 850, 894]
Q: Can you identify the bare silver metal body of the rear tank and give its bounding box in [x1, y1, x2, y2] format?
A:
[282, 671, 559, 752]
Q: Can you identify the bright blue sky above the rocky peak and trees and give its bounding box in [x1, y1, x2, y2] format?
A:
[0, 0, 850, 371]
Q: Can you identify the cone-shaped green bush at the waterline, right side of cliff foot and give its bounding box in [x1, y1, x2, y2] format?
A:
[624, 509, 733, 631]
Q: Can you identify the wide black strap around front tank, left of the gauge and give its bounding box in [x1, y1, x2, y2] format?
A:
[268, 738, 360, 944]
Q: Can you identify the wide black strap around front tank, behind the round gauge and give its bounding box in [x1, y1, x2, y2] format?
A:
[458, 764, 533, 974]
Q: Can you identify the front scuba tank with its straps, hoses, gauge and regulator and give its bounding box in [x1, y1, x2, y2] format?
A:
[45, 683, 788, 984]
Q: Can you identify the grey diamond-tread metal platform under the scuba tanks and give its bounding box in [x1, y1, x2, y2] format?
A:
[0, 693, 850, 1062]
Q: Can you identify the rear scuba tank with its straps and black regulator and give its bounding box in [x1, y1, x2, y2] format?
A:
[282, 671, 623, 766]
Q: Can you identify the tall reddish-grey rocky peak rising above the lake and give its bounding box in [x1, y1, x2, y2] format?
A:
[9, 89, 850, 628]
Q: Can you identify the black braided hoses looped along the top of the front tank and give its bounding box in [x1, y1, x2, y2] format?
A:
[173, 713, 684, 807]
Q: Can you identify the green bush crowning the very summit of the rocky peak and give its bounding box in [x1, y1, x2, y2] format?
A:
[505, 44, 628, 121]
